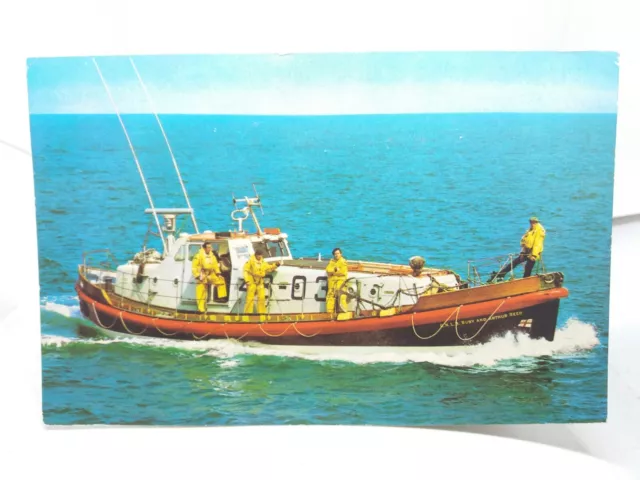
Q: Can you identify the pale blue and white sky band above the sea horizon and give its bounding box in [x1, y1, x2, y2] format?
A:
[27, 52, 618, 115]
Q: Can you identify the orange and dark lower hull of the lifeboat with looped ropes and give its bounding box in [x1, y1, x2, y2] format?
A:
[76, 286, 568, 347]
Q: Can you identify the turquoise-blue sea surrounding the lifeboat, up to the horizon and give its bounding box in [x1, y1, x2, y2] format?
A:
[31, 114, 616, 425]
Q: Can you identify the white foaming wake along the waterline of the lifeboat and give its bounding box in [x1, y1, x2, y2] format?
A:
[42, 318, 600, 370]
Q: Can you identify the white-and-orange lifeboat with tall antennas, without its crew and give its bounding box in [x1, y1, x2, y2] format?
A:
[75, 60, 569, 349]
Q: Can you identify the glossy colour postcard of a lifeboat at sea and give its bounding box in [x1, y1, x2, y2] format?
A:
[28, 52, 618, 426]
